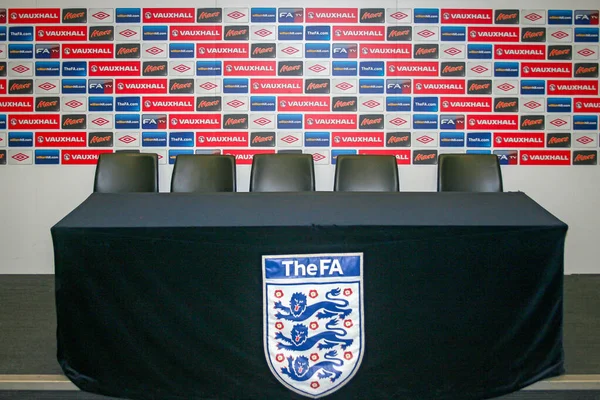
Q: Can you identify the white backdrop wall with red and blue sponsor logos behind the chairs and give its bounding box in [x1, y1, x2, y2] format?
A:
[0, 0, 600, 274]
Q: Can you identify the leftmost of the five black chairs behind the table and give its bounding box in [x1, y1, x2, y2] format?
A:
[94, 153, 158, 193]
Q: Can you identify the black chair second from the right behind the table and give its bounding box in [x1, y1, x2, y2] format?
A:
[333, 155, 400, 192]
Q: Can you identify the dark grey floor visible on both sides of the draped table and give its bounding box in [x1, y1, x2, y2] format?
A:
[0, 275, 600, 400]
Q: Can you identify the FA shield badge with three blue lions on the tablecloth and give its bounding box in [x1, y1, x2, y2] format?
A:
[262, 253, 365, 398]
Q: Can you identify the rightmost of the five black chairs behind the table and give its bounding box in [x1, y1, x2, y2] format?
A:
[438, 154, 503, 192]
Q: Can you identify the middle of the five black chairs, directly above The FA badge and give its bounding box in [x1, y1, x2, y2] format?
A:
[250, 153, 315, 192]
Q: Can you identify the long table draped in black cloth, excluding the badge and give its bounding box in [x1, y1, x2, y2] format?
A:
[52, 192, 567, 400]
